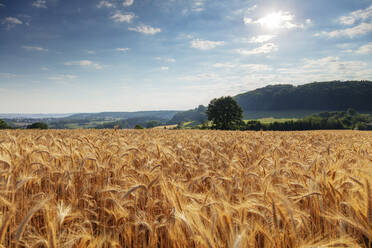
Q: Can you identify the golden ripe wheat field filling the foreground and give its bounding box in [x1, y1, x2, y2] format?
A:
[0, 130, 372, 248]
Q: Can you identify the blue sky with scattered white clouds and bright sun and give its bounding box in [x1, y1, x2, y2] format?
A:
[0, 0, 372, 113]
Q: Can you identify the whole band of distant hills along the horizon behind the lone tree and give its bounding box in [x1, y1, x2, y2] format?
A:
[0, 81, 372, 129]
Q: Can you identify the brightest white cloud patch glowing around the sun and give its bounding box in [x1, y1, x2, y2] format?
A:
[244, 11, 309, 29]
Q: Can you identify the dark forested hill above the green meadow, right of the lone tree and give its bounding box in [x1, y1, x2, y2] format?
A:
[235, 81, 372, 111]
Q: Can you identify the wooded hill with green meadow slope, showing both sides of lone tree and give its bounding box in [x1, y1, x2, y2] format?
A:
[169, 81, 372, 124]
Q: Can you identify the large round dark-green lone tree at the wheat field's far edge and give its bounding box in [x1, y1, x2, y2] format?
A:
[207, 96, 243, 130]
